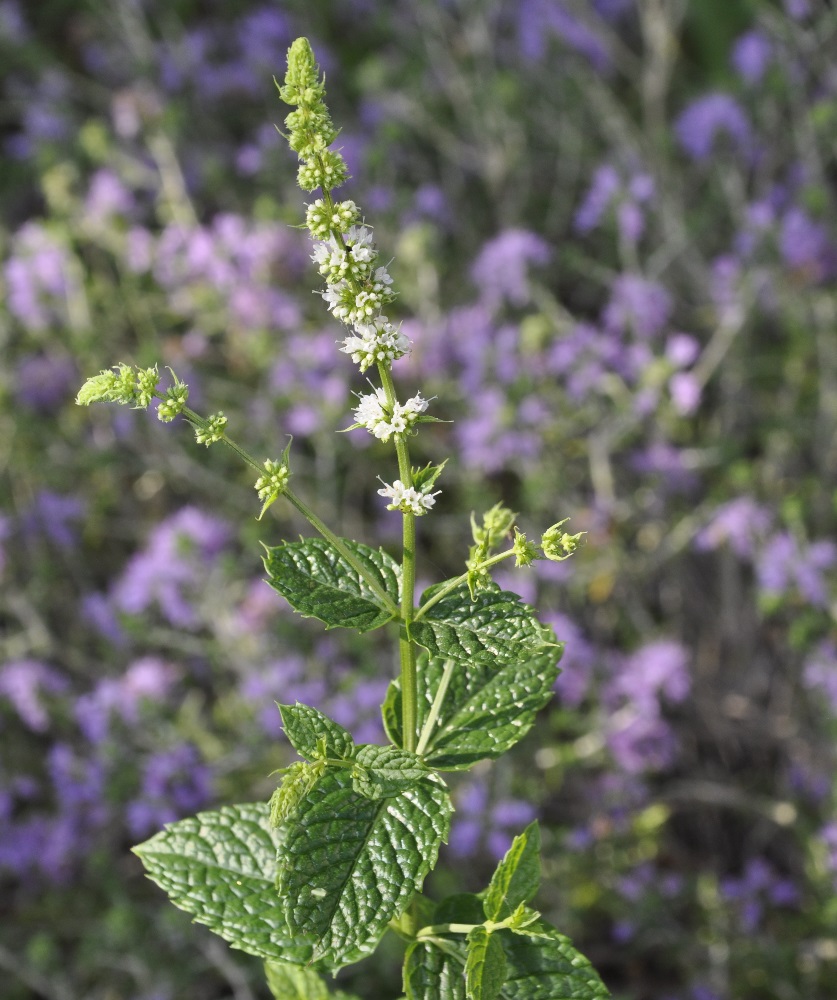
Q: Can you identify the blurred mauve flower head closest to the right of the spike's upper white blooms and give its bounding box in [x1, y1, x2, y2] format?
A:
[471, 229, 550, 309]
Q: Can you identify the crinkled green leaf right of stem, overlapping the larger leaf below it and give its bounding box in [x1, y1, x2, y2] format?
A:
[410, 583, 556, 664]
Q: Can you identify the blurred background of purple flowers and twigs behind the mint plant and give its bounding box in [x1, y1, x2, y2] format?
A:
[0, 0, 837, 1000]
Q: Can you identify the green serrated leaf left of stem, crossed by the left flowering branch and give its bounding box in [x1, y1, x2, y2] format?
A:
[265, 538, 401, 632]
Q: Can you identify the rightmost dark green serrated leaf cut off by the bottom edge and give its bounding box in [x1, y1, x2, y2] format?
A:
[499, 920, 610, 1000]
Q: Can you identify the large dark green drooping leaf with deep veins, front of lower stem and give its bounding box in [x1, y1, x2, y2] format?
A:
[276, 768, 452, 968]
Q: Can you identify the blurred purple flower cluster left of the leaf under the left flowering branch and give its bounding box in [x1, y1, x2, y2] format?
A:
[111, 507, 230, 628]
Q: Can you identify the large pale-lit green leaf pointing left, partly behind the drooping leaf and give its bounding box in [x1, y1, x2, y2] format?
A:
[134, 803, 311, 962]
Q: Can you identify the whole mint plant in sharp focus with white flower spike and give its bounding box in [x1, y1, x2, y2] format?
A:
[77, 38, 609, 1000]
